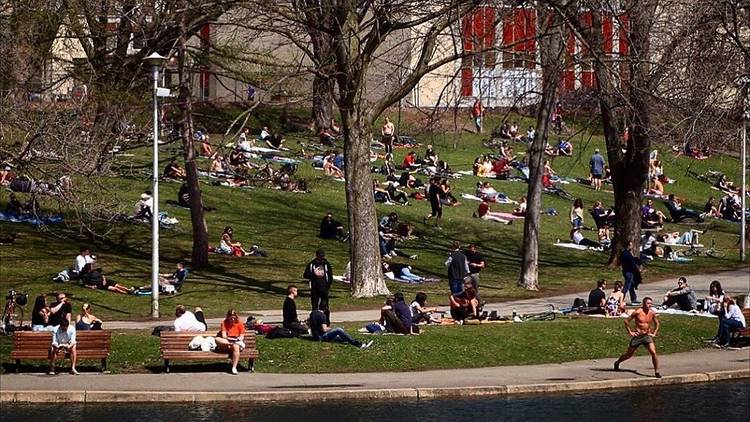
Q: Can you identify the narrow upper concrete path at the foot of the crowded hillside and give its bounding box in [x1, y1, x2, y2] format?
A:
[106, 267, 750, 329]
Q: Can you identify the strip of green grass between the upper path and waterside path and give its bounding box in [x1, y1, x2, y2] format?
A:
[0, 316, 716, 373]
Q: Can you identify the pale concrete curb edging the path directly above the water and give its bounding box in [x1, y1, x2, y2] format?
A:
[0, 369, 750, 404]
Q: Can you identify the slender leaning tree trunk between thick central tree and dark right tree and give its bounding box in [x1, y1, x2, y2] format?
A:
[518, 7, 564, 290]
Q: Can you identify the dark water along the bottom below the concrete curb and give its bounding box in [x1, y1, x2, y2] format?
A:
[0, 380, 750, 422]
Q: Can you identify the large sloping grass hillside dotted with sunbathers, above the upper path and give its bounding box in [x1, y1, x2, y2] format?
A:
[0, 110, 740, 322]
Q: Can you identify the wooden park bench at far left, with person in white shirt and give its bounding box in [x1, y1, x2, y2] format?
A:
[10, 330, 112, 372]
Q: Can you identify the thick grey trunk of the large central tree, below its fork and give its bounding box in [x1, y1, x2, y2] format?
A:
[341, 109, 390, 297]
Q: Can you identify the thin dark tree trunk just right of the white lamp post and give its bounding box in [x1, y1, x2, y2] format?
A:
[178, 2, 208, 269]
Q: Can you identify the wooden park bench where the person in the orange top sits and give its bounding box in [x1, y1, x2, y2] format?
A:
[159, 331, 259, 373]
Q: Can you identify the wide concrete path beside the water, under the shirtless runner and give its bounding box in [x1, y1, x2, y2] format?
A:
[0, 349, 750, 403]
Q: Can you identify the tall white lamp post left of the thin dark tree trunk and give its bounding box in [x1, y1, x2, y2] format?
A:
[143, 52, 167, 318]
